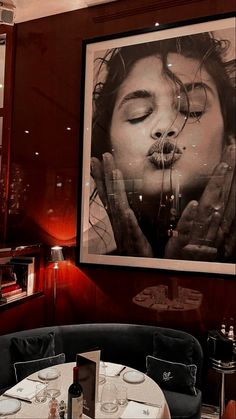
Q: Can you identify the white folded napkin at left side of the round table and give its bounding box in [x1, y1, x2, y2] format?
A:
[4, 378, 47, 401]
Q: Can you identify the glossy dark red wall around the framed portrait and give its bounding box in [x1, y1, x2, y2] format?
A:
[2, 0, 236, 406]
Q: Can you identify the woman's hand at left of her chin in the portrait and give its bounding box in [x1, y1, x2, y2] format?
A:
[91, 153, 153, 257]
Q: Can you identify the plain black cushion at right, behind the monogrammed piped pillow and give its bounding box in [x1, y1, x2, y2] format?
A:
[152, 331, 194, 364]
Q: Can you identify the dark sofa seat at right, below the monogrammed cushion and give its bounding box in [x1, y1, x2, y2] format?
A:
[163, 389, 202, 419]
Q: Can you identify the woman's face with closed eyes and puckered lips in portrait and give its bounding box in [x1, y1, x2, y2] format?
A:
[110, 53, 223, 199]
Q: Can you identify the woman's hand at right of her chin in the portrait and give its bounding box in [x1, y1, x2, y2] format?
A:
[165, 144, 236, 261]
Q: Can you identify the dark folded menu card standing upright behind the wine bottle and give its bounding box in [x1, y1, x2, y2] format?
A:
[76, 350, 101, 419]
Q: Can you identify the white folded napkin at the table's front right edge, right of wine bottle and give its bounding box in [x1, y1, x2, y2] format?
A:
[120, 402, 159, 419]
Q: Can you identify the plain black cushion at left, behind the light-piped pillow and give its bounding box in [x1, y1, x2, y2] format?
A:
[10, 332, 55, 363]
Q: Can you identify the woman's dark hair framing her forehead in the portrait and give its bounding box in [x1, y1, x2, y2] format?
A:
[91, 32, 235, 158]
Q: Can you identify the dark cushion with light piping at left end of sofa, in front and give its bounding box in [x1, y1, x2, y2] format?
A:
[14, 353, 65, 383]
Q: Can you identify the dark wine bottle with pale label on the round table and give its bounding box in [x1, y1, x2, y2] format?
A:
[67, 366, 83, 419]
